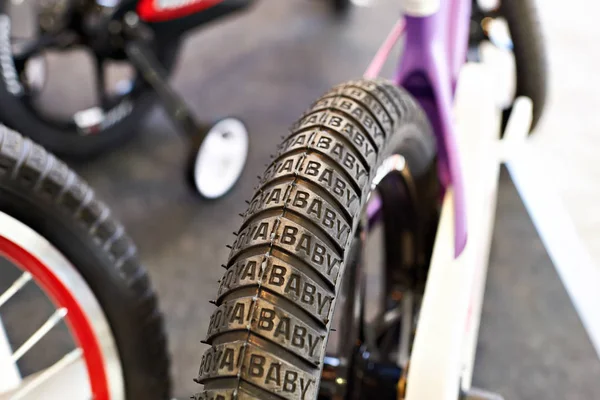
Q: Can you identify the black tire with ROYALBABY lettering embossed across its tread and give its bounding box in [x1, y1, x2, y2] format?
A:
[197, 80, 435, 400]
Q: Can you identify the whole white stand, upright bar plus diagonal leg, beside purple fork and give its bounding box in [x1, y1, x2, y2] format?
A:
[406, 57, 600, 400]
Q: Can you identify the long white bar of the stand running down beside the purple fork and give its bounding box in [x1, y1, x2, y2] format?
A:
[406, 64, 500, 400]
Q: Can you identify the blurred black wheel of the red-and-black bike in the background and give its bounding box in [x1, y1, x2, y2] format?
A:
[0, 0, 179, 159]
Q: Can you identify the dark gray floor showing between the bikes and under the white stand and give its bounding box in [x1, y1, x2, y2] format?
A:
[4, 0, 600, 400]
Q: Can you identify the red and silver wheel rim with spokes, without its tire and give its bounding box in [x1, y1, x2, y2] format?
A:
[0, 212, 124, 400]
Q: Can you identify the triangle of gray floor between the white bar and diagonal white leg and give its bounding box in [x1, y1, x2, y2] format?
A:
[474, 170, 600, 400]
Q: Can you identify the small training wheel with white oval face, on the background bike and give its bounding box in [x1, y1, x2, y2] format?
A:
[189, 118, 249, 199]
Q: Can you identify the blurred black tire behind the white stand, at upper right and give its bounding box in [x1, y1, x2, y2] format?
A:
[499, 0, 548, 131]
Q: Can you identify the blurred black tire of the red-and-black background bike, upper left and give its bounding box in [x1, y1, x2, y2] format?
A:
[0, 5, 179, 160]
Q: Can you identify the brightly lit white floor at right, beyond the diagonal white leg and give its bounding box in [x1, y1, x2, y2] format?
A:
[535, 0, 600, 268]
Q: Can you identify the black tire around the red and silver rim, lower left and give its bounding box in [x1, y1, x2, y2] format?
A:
[0, 125, 171, 400]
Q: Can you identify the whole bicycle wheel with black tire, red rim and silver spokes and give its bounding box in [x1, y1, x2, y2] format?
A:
[0, 127, 170, 400]
